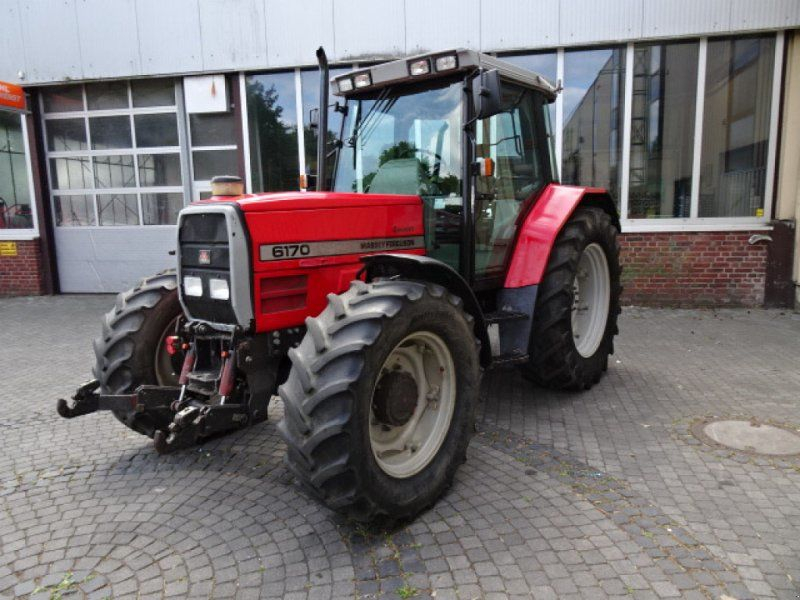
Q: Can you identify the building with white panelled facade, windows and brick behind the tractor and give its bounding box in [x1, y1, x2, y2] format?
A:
[0, 0, 800, 306]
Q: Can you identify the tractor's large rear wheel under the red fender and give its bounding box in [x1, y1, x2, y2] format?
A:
[523, 207, 622, 390]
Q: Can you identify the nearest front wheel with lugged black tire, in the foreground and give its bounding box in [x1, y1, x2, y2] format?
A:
[278, 281, 480, 521]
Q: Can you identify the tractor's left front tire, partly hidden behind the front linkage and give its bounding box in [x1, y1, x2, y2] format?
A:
[93, 270, 183, 437]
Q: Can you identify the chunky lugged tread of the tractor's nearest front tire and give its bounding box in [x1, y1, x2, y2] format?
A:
[278, 280, 477, 521]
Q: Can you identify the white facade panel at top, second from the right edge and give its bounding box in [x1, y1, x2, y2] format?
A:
[642, 0, 732, 38]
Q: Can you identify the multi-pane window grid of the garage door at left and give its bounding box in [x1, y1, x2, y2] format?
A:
[42, 79, 184, 227]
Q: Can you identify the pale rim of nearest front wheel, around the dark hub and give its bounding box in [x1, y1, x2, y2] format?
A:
[369, 331, 456, 479]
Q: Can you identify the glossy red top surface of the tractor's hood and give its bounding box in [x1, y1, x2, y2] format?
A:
[196, 192, 422, 212]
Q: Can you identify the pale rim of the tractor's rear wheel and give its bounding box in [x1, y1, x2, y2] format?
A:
[572, 243, 611, 358]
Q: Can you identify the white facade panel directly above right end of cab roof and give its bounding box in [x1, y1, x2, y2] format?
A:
[482, 0, 559, 52]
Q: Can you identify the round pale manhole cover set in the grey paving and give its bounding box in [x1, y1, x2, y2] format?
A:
[692, 420, 800, 456]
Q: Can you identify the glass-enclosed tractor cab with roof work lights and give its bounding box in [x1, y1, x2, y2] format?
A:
[328, 50, 557, 290]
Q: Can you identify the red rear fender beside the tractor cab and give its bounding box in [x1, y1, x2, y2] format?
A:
[505, 183, 620, 288]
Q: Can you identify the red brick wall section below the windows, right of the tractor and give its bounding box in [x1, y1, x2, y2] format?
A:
[620, 231, 767, 306]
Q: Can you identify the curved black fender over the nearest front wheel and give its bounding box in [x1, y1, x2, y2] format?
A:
[361, 254, 492, 367]
